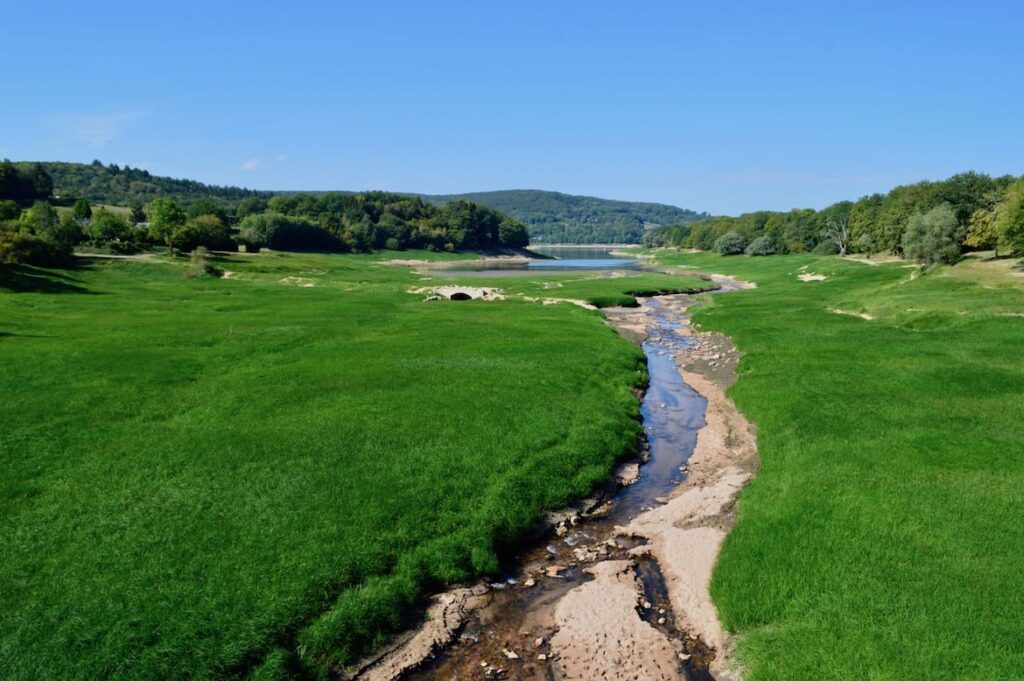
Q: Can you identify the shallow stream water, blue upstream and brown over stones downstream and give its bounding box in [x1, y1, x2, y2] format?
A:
[399, 270, 711, 679]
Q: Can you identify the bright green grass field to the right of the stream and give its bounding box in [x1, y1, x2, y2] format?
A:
[647, 252, 1024, 680]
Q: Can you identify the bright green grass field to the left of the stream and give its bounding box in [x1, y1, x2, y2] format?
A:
[0, 254, 700, 679]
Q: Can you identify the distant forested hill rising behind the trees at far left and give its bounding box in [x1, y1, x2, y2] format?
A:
[15, 161, 271, 207]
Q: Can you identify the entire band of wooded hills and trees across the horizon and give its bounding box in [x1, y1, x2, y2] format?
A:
[8, 161, 1024, 263]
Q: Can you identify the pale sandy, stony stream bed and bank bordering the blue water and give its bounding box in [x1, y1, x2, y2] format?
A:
[349, 275, 757, 681]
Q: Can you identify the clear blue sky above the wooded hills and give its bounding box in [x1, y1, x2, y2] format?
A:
[0, 0, 1024, 214]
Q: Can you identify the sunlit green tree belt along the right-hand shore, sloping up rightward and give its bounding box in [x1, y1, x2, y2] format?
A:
[644, 171, 1024, 262]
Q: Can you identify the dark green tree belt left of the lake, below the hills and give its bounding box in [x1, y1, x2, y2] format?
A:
[0, 161, 528, 264]
